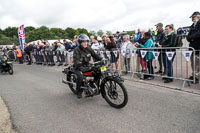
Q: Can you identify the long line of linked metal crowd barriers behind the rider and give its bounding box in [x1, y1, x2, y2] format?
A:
[28, 47, 200, 89]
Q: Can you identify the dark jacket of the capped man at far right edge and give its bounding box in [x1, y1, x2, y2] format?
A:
[187, 20, 200, 53]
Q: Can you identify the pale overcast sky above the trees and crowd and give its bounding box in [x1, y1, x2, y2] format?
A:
[0, 0, 200, 32]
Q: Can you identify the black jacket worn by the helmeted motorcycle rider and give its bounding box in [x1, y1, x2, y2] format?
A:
[73, 46, 102, 72]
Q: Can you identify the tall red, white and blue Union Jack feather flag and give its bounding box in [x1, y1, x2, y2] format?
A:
[18, 25, 26, 52]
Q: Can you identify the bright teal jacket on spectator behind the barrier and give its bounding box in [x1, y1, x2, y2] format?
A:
[141, 38, 154, 60]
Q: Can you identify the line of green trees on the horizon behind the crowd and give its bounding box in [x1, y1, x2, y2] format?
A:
[0, 26, 135, 45]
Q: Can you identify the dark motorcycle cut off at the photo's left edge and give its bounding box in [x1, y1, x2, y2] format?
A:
[0, 52, 13, 75]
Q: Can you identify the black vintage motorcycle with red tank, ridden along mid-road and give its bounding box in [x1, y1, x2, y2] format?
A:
[62, 60, 128, 109]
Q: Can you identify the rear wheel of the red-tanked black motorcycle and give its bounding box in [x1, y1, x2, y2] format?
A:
[67, 73, 77, 94]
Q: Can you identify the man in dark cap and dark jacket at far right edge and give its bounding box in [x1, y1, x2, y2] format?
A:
[187, 12, 200, 83]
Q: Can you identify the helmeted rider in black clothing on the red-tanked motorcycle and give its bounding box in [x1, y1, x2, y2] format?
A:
[73, 34, 102, 98]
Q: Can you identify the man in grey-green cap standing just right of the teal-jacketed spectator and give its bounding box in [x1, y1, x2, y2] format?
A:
[155, 23, 165, 74]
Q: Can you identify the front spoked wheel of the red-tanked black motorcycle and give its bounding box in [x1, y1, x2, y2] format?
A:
[102, 79, 128, 109]
